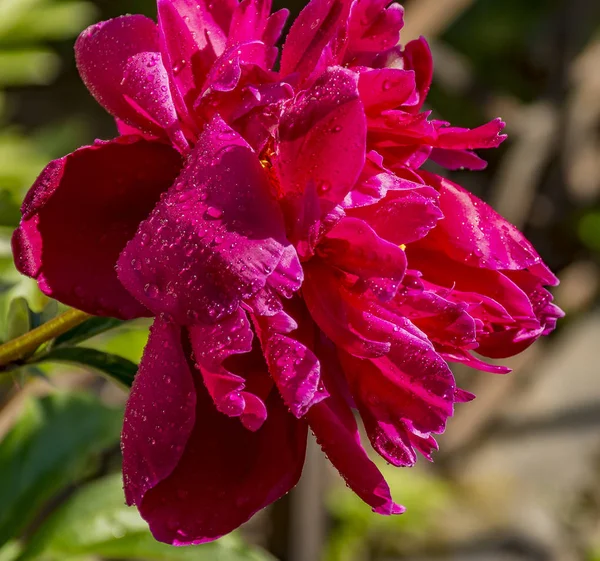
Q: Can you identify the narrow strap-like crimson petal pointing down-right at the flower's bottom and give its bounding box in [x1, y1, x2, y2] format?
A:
[306, 382, 404, 515]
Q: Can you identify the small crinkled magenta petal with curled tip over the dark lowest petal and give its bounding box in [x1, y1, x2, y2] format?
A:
[189, 309, 267, 430]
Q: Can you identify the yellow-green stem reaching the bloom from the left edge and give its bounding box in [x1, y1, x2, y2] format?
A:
[0, 309, 92, 369]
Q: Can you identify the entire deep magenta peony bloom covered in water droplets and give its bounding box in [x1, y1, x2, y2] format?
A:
[14, 0, 562, 545]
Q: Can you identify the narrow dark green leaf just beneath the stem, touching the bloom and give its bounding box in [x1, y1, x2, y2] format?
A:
[32, 347, 138, 388]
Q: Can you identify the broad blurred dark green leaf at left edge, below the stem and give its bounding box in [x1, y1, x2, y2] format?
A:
[0, 393, 122, 546]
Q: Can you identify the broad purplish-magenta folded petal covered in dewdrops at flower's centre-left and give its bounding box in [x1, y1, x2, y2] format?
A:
[118, 118, 289, 325]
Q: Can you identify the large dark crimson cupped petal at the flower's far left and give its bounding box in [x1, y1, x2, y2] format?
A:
[13, 137, 181, 319]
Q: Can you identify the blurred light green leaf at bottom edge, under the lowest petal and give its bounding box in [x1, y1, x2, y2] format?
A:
[18, 474, 273, 561]
